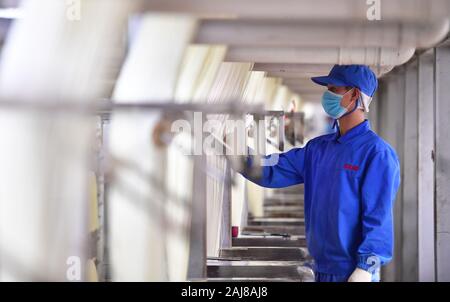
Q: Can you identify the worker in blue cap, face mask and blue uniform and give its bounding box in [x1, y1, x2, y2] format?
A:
[243, 65, 400, 282]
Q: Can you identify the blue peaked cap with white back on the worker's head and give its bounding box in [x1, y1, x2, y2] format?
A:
[311, 65, 378, 112]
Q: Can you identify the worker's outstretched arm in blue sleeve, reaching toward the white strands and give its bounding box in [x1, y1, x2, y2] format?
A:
[242, 148, 306, 188]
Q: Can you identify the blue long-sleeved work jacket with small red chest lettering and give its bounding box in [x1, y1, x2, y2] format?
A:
[244, 120, 400, 275]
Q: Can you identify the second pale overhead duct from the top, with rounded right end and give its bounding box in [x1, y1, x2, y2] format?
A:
[195, 19, 449, 48]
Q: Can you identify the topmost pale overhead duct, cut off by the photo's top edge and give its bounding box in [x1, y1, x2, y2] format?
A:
[145, 0, 450, 22]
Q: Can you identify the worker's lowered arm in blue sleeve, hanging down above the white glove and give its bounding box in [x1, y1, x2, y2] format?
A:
[357, 150, 400, 272]
